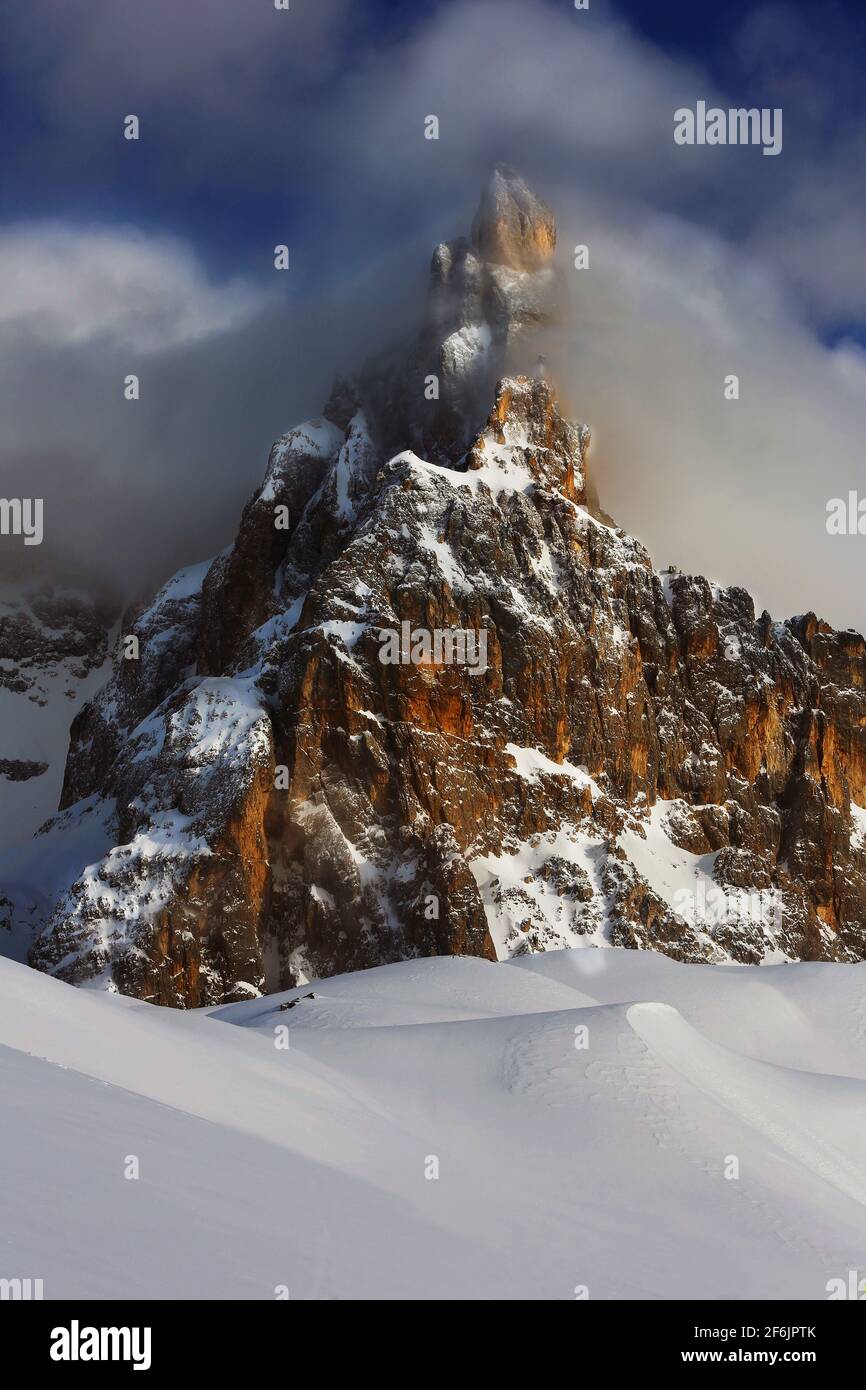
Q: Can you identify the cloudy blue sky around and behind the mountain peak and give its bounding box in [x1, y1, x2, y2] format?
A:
[0, 0, 866, 620]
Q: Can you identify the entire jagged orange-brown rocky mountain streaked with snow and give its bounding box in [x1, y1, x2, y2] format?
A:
[22, 168, 866, 1006]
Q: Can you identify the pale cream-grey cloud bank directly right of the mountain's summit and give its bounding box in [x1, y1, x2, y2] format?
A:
[544, 203, 866, 630]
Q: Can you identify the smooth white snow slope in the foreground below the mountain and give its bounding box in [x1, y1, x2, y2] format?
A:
[0, 949, 866, 1300]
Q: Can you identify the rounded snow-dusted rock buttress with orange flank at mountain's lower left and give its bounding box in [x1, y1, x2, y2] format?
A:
[31, 661, 272, 1005]
